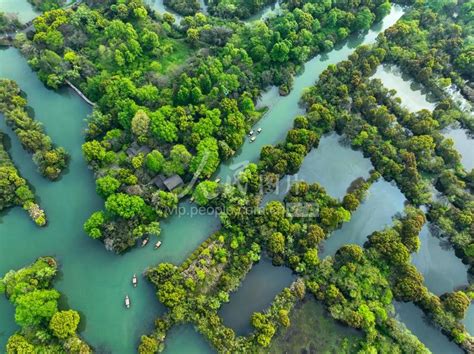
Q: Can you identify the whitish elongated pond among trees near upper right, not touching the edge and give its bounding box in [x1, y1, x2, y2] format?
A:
[372, 65, 435, 112]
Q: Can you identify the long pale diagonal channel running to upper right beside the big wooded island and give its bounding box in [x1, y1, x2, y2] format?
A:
[217, 6, 403, 182]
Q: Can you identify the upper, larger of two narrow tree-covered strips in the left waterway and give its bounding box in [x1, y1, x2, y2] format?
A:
[0, 79, 68, 181]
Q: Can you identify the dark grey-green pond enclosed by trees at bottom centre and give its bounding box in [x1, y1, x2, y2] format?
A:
[219, 258, 296, 335]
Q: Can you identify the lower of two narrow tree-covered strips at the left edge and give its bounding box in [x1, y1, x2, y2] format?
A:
[0, 131, 46, 226]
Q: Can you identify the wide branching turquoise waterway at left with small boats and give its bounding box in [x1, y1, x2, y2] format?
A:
[0, 49, 219, 353]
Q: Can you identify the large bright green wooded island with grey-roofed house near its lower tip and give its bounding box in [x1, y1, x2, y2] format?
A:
[12, 0, 390, 253]
